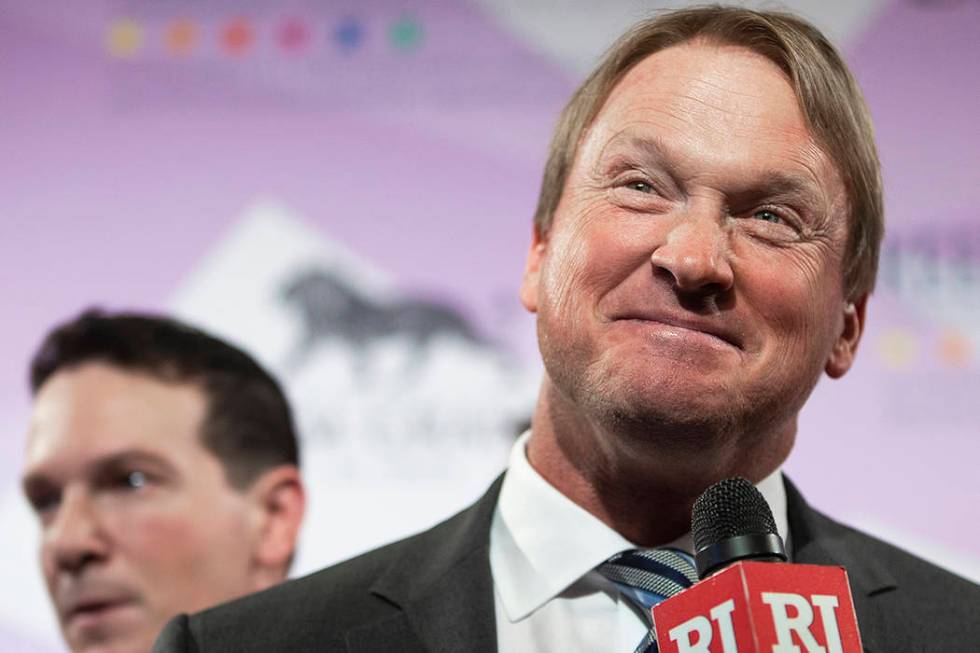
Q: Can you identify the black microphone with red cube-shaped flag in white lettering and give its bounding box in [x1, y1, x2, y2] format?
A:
[652, 478, 863, 653]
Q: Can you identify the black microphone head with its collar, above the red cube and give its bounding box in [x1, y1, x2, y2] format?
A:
[691, 477, 786, 578]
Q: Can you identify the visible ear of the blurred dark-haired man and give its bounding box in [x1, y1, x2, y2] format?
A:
[247, 465, 306, 590]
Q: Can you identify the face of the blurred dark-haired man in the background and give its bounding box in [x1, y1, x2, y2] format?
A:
[24, 363, 264, 653]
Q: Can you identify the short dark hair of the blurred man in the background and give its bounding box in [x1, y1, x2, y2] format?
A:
[30, 309, 299, 489]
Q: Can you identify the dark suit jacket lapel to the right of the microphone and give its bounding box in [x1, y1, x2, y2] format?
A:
[783, 476, 898, 651]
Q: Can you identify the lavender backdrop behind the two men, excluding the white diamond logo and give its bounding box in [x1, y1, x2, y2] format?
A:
[0, 0, 980, 651]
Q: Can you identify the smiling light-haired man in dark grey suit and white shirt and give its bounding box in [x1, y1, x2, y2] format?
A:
[157, 7, 980, 653]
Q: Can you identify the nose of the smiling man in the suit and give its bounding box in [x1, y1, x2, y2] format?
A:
[650, 213, 735, 295]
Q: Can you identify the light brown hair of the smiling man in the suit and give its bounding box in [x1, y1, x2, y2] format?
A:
[534, 5, 885, 299]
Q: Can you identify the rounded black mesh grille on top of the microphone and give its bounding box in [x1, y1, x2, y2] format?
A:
[691, 476, 776, 551]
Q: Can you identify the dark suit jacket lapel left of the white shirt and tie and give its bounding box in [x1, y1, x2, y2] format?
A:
[347, 477, 503, 653]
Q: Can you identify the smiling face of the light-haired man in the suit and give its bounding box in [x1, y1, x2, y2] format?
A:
[521, 44, 863, 444]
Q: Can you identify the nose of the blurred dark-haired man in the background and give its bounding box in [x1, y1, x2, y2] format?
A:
[44, 489, 108, 572]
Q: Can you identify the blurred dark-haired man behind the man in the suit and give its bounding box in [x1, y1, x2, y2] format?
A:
[23, 312, 304, 653]
